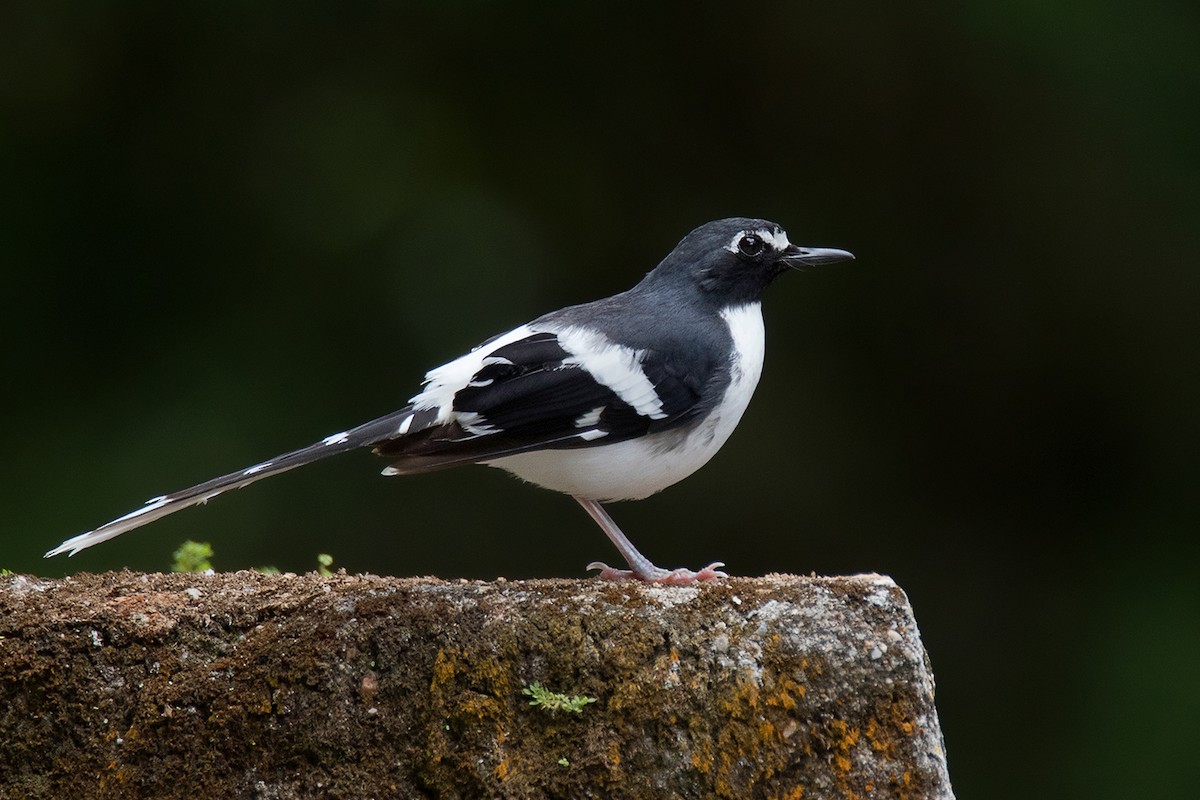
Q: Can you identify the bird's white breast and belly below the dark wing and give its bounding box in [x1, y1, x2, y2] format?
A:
[488, 302, 766, 501]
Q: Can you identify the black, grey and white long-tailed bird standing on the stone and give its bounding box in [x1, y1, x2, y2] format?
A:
[46, 217, 854, 584]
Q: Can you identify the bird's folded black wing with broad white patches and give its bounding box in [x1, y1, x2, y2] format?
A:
[374, 326, 719, 475]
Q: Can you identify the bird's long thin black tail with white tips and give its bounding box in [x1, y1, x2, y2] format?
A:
[46, 407, 413, 558]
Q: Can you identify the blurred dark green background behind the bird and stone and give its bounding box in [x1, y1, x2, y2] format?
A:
[0, 1, 1200, 799]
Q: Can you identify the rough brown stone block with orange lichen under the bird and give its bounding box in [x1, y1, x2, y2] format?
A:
[0, 572, 952, 799]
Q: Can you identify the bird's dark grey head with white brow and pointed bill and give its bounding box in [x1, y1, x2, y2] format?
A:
[647, 217, 854, 306]
